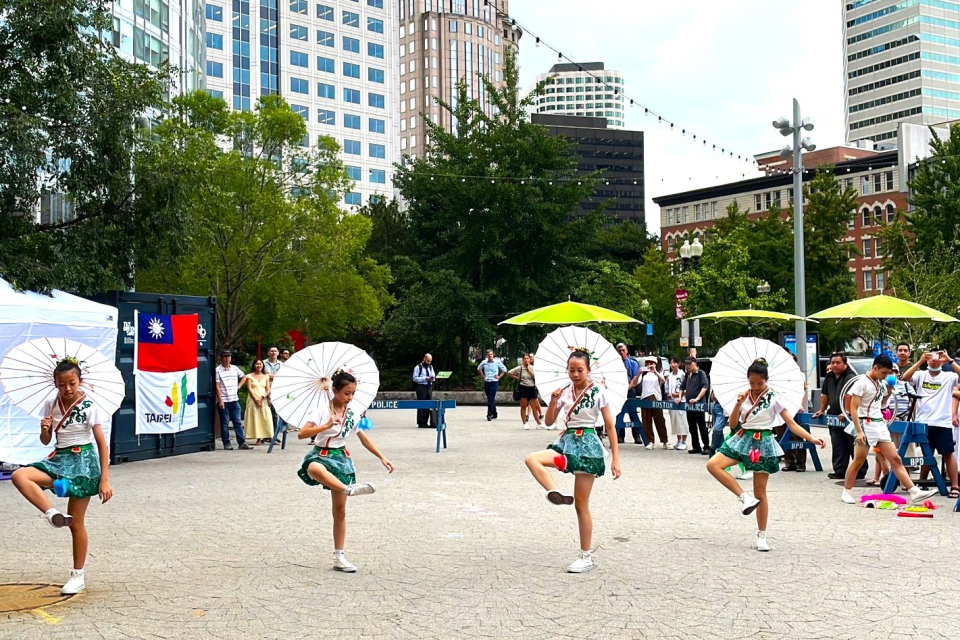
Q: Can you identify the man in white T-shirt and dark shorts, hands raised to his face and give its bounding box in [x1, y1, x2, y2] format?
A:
[902, 351, 960, 500]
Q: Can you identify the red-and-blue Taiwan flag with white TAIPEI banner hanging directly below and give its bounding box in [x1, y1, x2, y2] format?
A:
[133, 311, 200, 434]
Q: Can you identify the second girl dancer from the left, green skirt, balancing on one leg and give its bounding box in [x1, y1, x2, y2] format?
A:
[297, 371, 393, 573]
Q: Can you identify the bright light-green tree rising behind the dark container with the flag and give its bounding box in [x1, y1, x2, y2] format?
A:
[136, 91, 389, 347]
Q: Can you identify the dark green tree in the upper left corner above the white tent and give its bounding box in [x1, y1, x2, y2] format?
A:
[0, 0, 177, 293]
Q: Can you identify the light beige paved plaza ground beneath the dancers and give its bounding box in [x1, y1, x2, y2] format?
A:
[0, 407, 960, 640]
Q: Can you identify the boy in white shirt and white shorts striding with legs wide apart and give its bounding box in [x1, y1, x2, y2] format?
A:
[840, 354, 938, 504]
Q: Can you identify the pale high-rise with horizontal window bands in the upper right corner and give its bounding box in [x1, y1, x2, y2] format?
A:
[843, 0, 960, 148]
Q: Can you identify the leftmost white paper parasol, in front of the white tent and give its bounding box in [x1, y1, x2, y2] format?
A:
[0, 338, 125, 418]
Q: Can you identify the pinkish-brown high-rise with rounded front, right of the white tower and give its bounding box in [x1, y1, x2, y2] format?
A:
[396, 0, 522, 157]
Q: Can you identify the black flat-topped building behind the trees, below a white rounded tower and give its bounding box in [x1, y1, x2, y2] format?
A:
[531, 113, 646, 224]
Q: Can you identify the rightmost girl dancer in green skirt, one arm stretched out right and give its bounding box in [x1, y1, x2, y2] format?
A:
[707, 358, 826, 551]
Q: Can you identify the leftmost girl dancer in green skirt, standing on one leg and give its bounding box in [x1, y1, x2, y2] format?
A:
[13, 359, 113, 595]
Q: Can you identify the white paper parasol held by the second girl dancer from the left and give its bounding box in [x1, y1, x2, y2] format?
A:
[270, 342, 380, 427]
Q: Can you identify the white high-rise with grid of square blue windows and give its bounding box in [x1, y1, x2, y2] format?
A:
[205, 0, 402, 206]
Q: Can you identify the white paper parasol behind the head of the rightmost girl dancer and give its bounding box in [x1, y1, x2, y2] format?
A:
[710, 338, 806, 415]
